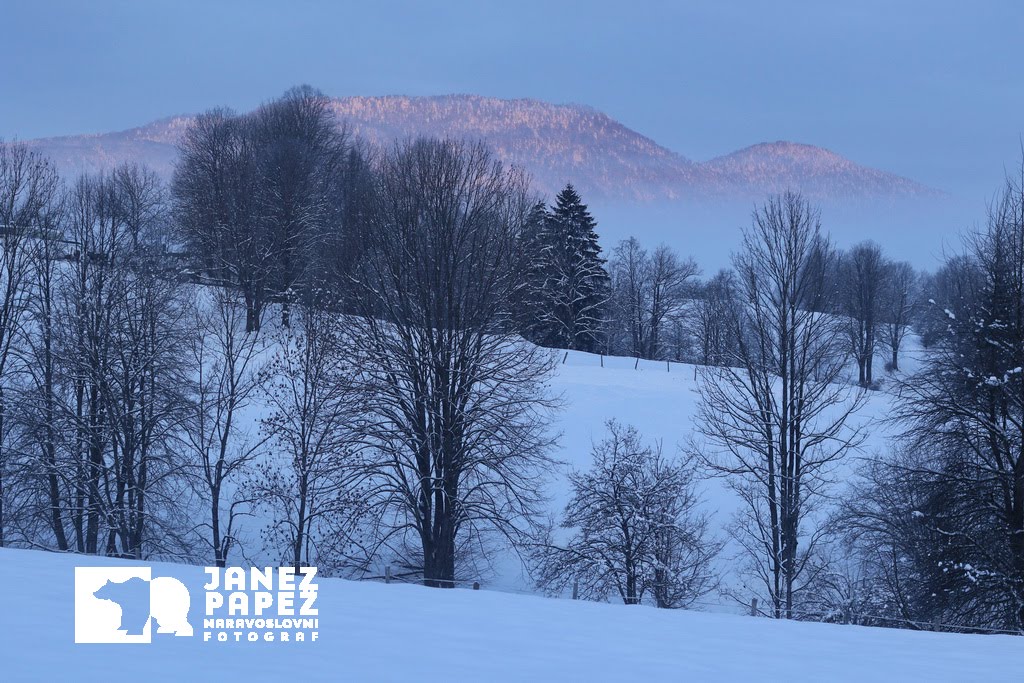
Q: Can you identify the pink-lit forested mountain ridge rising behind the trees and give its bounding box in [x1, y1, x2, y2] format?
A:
[22, 94, 936, 201]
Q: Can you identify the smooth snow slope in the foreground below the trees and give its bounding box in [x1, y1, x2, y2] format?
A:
[0, 550, 1024, 683]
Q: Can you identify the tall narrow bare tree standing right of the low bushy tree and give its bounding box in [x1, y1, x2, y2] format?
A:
[696, 193, 862, 617]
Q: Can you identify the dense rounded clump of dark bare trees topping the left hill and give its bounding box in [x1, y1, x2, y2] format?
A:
[173, 86, 370, 331]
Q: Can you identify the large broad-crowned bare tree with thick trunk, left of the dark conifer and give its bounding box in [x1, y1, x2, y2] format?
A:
[348, 140, 553, 587]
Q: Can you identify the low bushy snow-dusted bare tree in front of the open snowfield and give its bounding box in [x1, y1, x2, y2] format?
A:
[539, 420, 721, 608]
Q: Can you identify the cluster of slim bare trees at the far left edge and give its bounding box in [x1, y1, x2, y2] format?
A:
[0, 156, 193, 557]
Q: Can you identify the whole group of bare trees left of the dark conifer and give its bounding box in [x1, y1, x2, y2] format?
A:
[0, 112, 573, 586]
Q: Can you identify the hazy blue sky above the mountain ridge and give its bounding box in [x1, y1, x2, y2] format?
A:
[0, 0, 1024, 203]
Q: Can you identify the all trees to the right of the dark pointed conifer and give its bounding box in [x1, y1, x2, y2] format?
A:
[539, 177, 1024, 632]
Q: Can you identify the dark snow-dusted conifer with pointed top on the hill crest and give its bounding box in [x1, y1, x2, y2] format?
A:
[526, 184, 608, 351]
